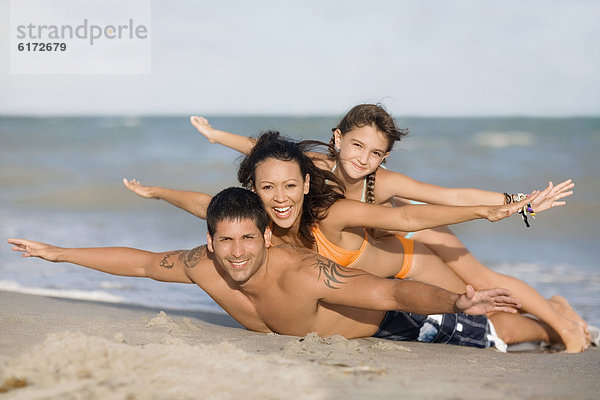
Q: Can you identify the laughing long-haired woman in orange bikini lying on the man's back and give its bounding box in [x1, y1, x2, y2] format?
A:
[125, 133, 583, 351]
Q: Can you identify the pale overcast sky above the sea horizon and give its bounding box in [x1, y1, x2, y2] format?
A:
[0, 0, 600, 116]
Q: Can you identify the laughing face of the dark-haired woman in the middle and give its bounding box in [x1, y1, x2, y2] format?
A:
[254, 158, 310, 229]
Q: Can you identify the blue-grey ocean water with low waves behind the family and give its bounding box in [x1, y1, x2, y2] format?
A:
[0, 116, 600, 325]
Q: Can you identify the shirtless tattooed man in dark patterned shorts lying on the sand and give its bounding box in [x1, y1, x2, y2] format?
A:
[8, 188, 547, 347]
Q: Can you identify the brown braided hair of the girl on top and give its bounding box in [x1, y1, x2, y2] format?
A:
[328, 104, 408, 203]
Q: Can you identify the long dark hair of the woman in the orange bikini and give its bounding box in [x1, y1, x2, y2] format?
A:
[238, 131, 344, 245]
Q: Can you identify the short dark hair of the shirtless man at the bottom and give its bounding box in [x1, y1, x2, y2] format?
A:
[206, 187, 270, 237]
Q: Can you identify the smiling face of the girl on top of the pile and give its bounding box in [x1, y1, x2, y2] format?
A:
[335, 125, 390, 179]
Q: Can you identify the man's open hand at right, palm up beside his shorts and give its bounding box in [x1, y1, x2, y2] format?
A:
[455, 285, 521, 315]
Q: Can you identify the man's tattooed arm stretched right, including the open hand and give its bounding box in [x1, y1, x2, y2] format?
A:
[301, 257, 520, 315]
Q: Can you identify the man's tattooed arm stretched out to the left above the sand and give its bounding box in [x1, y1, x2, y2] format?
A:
[8, 239, 206, 283]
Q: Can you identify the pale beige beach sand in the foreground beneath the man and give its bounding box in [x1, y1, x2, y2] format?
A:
[0, 292, 600, 400]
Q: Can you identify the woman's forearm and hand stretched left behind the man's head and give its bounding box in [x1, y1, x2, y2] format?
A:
[123, 178, 212, 219]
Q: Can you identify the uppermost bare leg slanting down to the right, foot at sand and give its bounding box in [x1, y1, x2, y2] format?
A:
[414, 227, 589, 353]
